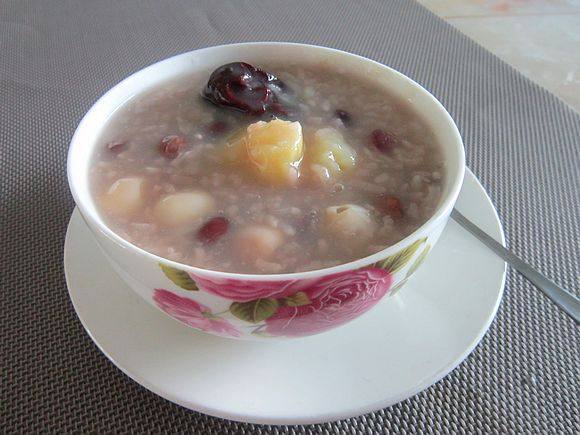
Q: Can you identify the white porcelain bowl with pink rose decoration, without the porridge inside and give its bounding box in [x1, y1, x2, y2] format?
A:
[67, 42, 465, 340]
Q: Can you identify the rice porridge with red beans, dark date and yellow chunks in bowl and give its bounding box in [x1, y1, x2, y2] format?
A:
[90, 62, 445, 274]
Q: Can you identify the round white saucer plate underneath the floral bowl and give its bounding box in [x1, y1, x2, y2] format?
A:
[64, 171, 505, 424]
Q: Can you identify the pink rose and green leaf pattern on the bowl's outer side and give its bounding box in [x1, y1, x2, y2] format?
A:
[153, 238, 430, 337]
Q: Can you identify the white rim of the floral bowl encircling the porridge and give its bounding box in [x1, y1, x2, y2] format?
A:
[67, 41, 465, 281]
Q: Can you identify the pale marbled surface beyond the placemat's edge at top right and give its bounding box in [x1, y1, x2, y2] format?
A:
[419, 0, 580, 112]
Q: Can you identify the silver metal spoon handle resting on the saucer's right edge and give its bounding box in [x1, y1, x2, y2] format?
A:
[451, 209, 580, 324]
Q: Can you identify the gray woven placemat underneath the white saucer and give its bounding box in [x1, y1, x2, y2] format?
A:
[0, 0, 580, 433]
